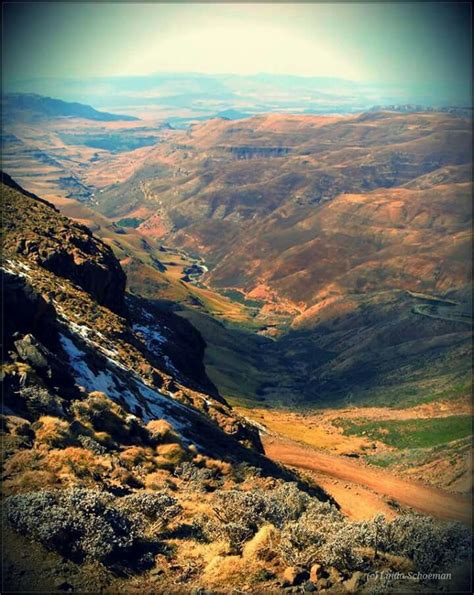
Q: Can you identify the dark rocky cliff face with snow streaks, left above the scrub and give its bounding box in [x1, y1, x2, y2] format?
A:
[2, 176, 260, 451]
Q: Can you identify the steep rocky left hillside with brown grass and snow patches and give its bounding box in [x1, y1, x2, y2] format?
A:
[2, 179, 262, 450]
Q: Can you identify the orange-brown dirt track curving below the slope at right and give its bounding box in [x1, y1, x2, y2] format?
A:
[262, 435, 471, 525]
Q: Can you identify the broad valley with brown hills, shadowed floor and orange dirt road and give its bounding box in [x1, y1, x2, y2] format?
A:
[1, 96, 472, 564]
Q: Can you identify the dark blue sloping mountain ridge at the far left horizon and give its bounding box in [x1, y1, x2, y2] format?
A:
[2, 93, 139, 122]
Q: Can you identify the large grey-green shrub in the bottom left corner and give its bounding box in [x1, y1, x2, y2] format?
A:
[5, 488, 179, 564]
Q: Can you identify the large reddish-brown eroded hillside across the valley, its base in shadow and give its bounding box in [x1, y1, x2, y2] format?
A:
[83, 112, 472, 405]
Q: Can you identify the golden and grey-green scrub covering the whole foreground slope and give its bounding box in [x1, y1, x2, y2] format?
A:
[3, 393, 470, 591]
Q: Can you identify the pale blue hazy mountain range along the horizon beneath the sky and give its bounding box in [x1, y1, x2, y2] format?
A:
[4, 73, 470, 121]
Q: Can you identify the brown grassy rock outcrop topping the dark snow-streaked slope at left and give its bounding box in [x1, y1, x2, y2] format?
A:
[2, 173, 126, 315]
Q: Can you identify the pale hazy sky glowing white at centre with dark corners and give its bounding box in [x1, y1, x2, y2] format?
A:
[3, 2, 471, 87]
